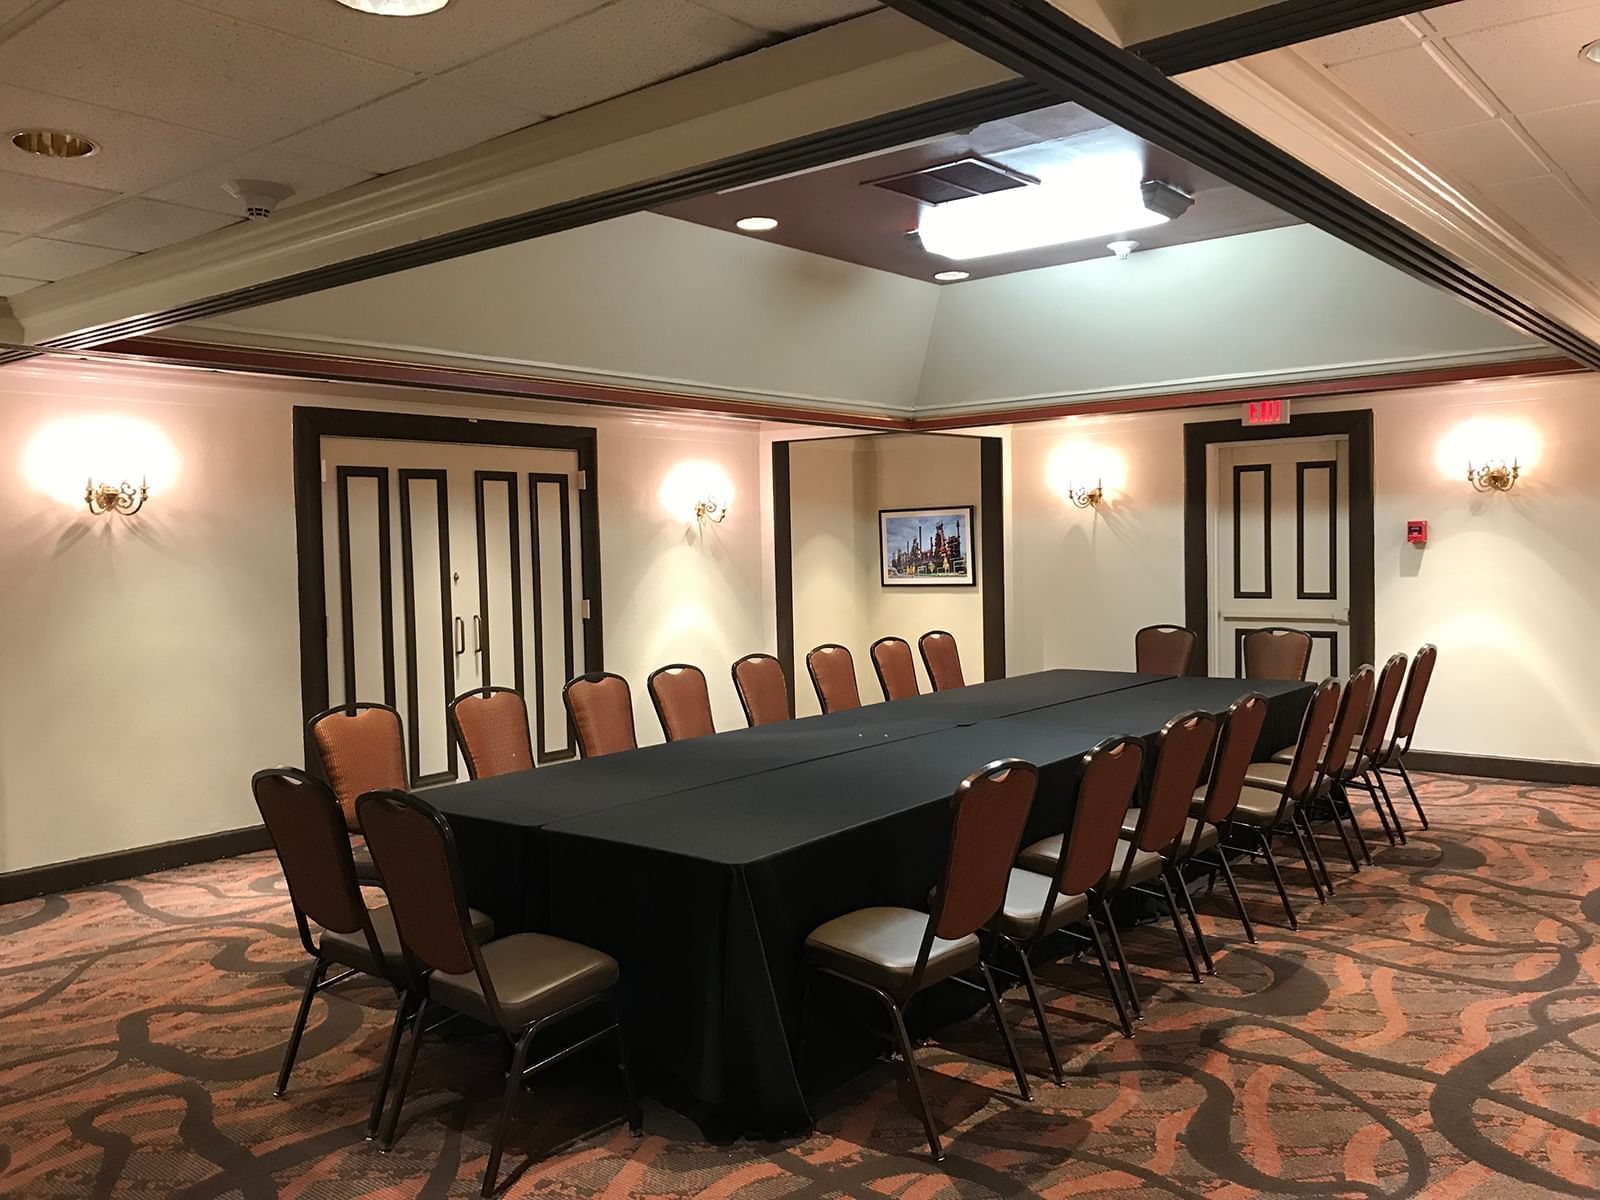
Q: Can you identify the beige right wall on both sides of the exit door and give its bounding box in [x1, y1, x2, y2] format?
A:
[1010, 374, 1600, 763]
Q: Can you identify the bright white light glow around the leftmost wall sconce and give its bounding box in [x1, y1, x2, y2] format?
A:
[22, 414, 179, 509]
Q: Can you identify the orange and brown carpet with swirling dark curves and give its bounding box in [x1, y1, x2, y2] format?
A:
[0, 778, 1600, 1200]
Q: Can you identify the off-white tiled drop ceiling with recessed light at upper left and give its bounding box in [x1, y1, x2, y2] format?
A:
[0, 0, 878, 296]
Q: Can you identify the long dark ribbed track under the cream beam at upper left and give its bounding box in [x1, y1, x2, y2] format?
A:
[34, 80, 1054, 350]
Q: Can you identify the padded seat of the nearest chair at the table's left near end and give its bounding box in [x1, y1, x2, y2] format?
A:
[427, 933, 621, 1030]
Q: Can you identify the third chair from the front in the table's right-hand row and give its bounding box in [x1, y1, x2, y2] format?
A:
[1106, 709, 1216, 1013]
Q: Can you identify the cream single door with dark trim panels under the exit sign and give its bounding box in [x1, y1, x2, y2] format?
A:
[1206, 437, 1350, 678]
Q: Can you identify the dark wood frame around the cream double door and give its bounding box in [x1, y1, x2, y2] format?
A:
[294, 406, 605, 729]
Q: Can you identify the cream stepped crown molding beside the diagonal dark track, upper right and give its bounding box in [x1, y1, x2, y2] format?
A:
[1176, 50, 1600, 341]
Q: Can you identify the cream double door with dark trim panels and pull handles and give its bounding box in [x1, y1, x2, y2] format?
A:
[322, 437, 586, 786]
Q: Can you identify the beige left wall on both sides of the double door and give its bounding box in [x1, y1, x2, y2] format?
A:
[0, 363, 773, 870]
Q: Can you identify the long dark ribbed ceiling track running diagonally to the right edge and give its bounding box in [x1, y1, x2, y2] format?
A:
[886, 0, 1600, 368]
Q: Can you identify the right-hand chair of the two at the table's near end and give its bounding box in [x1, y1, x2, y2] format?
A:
[357, 790, 642, 1197]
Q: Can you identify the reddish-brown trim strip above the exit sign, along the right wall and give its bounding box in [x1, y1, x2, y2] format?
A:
[912, 358, 1586, 432]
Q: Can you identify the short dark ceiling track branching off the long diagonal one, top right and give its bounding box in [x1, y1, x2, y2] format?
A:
[1128, 0, 1448, 75]
